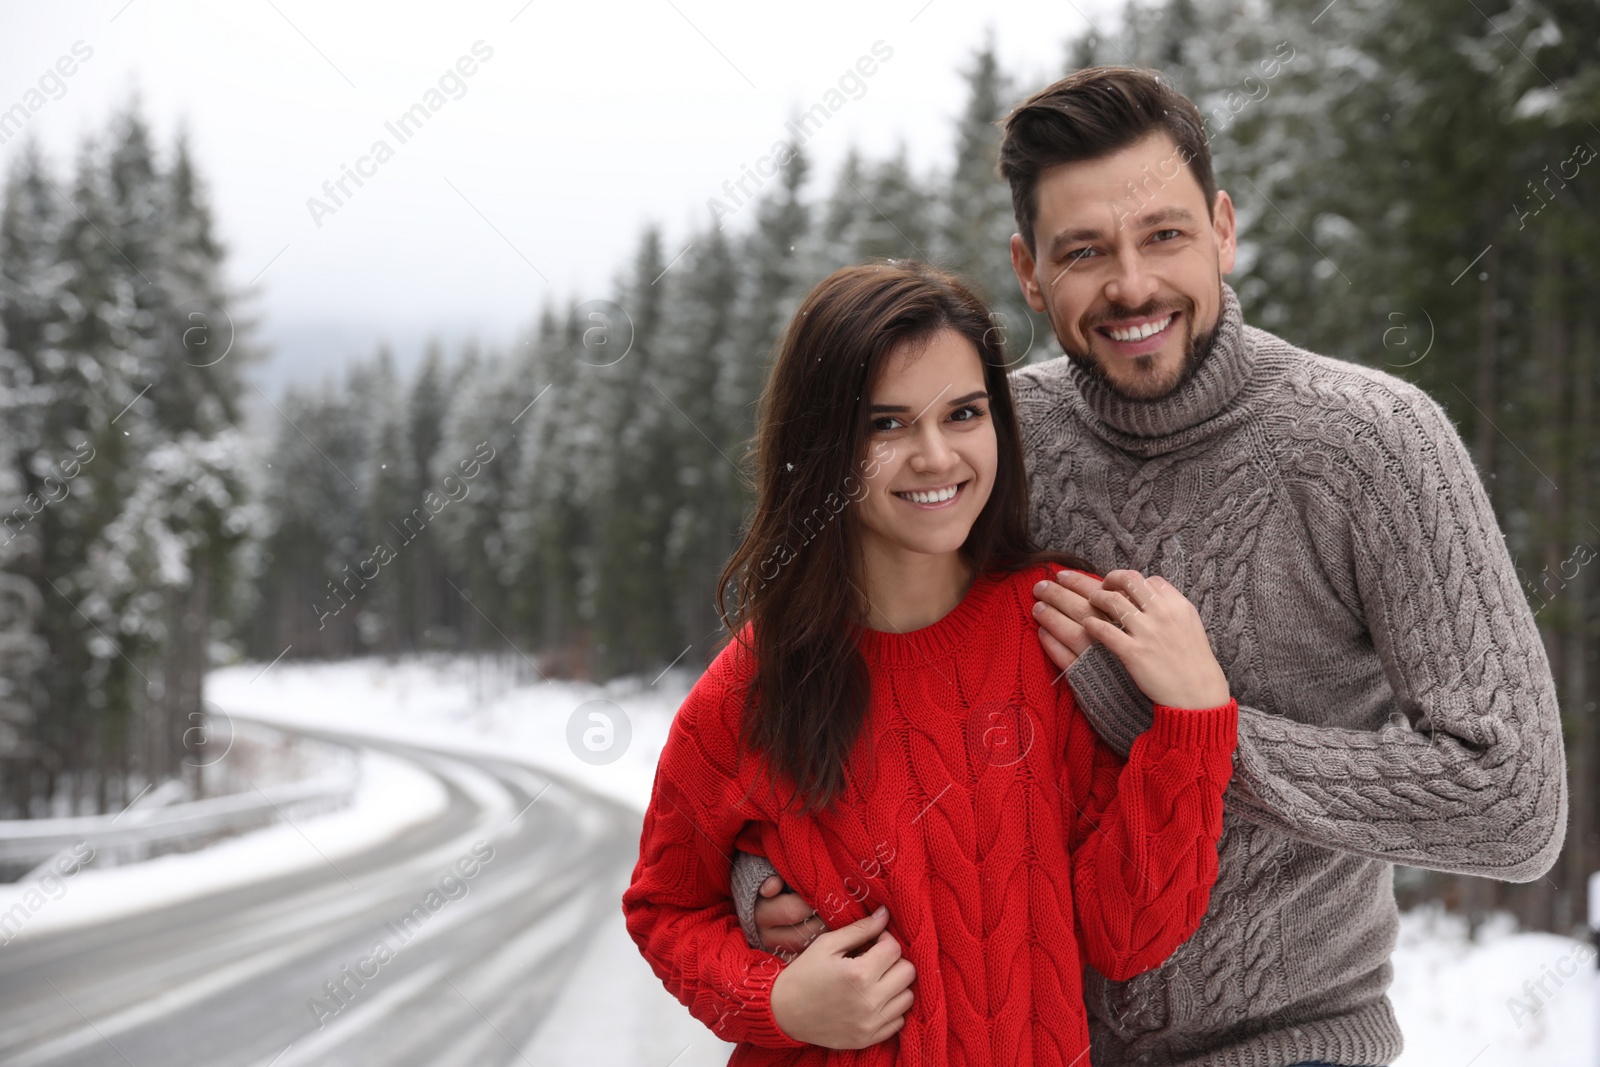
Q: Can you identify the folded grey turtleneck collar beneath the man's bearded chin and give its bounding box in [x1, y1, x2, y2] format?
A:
[1069, 282, 1254, 456]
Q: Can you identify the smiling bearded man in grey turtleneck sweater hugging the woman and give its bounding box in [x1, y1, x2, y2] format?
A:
[734, 67, 1566, 1067]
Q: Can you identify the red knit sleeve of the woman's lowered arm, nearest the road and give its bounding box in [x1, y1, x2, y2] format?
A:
[622, 659, 803, 1048]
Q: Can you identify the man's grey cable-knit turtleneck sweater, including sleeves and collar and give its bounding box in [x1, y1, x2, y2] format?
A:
[734, 285, 1566, 1067]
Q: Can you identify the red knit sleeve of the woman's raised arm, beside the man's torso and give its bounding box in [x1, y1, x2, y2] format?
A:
[1061, 689, 1238, 981]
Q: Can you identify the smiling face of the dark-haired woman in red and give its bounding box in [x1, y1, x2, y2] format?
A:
[861, 330, 998, 563]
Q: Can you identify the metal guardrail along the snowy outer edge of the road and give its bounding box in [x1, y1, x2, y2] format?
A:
[0, 774, 358, 870]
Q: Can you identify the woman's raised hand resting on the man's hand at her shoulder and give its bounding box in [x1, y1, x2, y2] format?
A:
[1034, 569, 1229, 709]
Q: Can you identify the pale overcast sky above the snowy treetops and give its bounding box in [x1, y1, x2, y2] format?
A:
[0, 0, 1120, 395]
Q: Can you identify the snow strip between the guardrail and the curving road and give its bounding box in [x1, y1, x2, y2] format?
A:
[0, 750, 446, 937]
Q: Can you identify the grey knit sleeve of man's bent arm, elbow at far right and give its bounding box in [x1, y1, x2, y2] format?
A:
[1067, 379, 1568, 881]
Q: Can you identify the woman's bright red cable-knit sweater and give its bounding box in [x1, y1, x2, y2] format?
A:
[622, 566, 1238, 1067]
